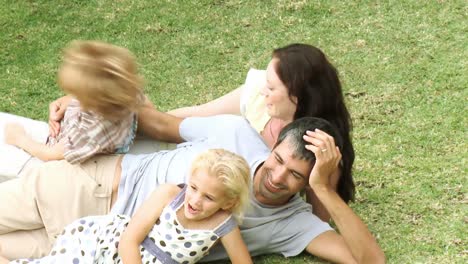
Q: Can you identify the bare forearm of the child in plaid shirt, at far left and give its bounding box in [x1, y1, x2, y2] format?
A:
[5, 123, 65, 161]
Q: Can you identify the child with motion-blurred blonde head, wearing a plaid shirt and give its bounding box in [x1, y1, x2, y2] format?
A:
[5, 41, 144, 163]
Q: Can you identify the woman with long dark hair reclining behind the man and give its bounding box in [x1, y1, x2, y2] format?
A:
[169, 44, 354, 221]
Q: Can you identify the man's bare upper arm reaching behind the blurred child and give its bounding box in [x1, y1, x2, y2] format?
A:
[138, 98, 183, 143]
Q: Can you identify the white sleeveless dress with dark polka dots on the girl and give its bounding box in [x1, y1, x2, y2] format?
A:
[10, 187, 236, 264]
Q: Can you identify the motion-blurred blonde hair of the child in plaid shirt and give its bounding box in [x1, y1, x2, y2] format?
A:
[58, 41, 144, 120]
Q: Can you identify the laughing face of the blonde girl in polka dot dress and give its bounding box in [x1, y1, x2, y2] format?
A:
[184, 169, 235, 220]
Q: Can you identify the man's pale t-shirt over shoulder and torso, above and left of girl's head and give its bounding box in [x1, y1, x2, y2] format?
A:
[111, 115, 270, 215]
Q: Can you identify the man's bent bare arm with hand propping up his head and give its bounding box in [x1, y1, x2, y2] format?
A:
[304, 130, 385, 263]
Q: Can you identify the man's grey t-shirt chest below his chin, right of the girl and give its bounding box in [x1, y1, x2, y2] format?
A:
[202, 178, 333, 262]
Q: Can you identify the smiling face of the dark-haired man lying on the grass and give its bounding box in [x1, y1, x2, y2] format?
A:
[254, 138, 312, 205]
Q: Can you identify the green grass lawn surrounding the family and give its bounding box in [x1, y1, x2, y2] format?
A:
[0, 0, 468, 263]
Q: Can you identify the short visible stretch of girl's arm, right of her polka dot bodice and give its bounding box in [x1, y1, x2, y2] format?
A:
[221, 227, 253, 264]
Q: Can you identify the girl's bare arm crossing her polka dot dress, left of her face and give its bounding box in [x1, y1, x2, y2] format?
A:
[119, 185, 180, 264]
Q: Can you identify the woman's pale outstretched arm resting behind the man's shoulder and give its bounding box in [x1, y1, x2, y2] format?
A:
[167, 87, 242, 117]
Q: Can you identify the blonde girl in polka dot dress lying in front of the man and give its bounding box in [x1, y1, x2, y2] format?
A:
[0, 149, 252, 264]
